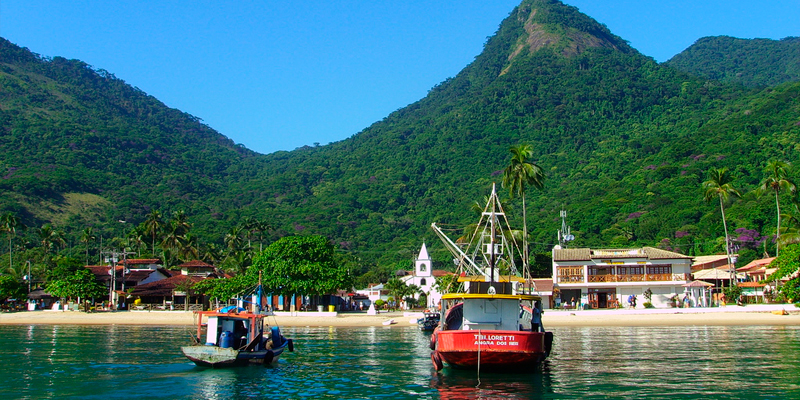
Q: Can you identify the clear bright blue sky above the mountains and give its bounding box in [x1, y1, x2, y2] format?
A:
[0, 0, 800, 153]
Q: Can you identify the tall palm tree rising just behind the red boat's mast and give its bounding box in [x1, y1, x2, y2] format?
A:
[503, 144, 544, 278]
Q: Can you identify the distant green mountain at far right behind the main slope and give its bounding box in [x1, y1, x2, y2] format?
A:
[666, 36, 800, 88]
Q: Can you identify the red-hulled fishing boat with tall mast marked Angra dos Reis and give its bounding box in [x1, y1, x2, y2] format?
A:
[430, 186, 553, 371]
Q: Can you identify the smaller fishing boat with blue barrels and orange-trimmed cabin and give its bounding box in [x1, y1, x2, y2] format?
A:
[181, 287, 294, 368]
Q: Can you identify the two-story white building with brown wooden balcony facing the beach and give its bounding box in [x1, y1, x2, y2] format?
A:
[553, 246, 692, 308]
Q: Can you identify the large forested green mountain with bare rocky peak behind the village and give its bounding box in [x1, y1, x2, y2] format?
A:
[0, 0, 800, 272]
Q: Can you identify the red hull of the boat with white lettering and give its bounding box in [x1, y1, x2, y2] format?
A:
[434, 330, 553, 370]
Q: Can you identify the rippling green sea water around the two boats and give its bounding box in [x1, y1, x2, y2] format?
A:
[0, 325, 800, 400]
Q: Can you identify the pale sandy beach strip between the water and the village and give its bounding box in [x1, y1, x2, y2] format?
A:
[0, 304, 800, 327]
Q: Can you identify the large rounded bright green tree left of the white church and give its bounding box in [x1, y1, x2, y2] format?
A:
[247, 235, 352, 295]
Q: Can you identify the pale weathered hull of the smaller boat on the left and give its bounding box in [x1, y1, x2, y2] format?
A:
[181, 345, 285, 368]
